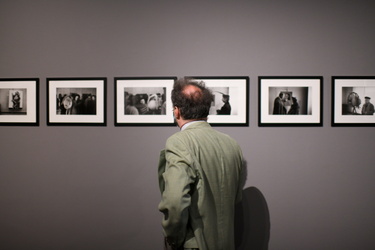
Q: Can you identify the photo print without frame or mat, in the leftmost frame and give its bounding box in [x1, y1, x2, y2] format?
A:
[0, 88, 27, 115]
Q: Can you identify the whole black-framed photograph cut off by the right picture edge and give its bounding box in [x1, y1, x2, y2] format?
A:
[332, 76, 375, 126]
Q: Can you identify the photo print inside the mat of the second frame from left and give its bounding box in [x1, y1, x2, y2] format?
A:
[56, 88, 96, 115]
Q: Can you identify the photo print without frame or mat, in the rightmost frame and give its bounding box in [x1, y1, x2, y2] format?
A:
[342, 87, 375, 115]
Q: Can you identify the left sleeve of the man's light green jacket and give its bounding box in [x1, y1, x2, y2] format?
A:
[159, 136, 195, 248]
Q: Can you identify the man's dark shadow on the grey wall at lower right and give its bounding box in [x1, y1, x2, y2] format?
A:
[235, 187, 271, 250]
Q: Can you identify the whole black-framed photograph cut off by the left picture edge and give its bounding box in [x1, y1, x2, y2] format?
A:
[0, 78, 39, 126]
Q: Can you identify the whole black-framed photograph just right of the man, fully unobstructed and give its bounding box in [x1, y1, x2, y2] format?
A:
[258, 76, 323, 126]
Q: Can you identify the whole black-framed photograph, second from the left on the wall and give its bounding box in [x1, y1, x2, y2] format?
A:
[47, 78, 107, 126]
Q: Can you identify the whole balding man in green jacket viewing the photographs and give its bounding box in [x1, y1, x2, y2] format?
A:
[158, 78, 245, 250]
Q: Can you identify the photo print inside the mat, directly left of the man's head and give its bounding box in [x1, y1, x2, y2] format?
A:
[124, 87, 166, 115]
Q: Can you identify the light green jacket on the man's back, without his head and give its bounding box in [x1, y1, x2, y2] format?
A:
[159, 122, 242, 250]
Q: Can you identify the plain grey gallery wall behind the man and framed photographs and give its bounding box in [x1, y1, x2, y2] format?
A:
[0, 0, 375, 250]
